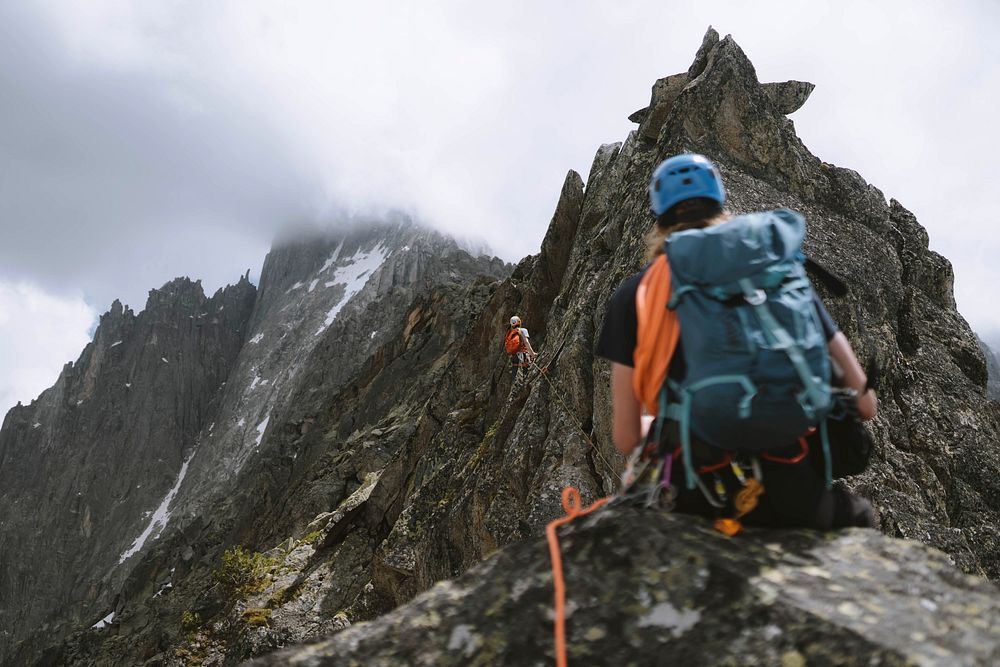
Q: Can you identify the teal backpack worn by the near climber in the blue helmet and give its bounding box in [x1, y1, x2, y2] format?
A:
[657, 209, 831, 489]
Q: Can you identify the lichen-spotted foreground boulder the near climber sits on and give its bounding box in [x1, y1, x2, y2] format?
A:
[252, 506, 1000, 667]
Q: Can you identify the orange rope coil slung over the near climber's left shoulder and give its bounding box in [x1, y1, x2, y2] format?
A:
[632, 255, 681, 415]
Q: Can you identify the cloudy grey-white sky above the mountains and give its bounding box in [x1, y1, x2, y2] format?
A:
[0, 0, 1000, 414]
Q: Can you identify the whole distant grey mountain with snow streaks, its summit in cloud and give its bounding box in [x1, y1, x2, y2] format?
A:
[0, 220, 510, 663]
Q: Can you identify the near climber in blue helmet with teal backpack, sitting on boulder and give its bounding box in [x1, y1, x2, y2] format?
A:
[597, 154, 877, 532]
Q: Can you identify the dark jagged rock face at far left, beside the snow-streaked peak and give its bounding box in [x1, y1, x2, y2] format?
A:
[0, 278, 256, 657]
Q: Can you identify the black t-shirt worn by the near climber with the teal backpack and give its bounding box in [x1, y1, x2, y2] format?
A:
[597, 269, 840, 370]
